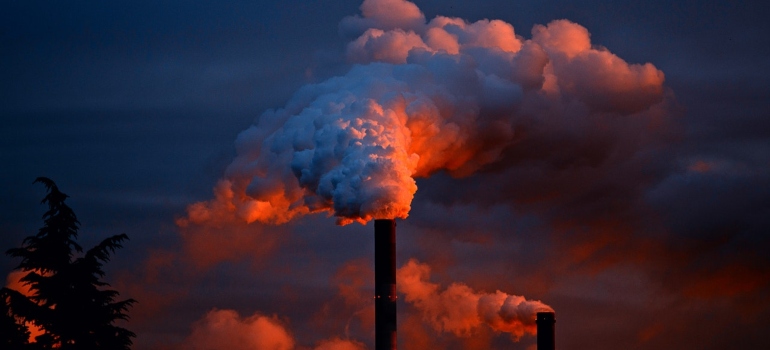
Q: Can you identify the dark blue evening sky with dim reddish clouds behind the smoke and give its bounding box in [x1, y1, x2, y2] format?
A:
[0, 0, 770, 349]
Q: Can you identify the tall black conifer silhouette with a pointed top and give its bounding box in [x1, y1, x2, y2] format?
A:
[7, 177, 136, 350]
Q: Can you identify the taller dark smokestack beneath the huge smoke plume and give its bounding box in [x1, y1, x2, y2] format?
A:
[374, 219, 396, 350]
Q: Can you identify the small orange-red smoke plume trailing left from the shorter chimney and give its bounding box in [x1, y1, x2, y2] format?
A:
[396, 259, 553, 340]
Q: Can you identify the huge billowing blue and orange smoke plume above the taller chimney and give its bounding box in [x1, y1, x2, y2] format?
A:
[185, 0, 664, 224]
